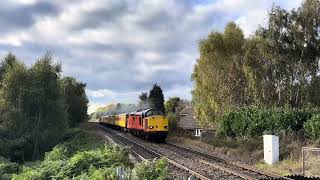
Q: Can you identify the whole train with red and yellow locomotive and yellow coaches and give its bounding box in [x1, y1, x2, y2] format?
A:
[99, 108, 169, 142]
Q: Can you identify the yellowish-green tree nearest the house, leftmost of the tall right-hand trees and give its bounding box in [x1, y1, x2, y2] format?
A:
[192, 23, 248, 122]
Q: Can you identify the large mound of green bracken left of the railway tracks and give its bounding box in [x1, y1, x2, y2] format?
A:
[10, 129, 132, 180]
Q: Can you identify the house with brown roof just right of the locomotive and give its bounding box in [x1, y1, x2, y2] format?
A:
[177, 106, 209, 137]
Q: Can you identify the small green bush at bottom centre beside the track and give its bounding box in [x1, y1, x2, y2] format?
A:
[133, 158, 169, 180]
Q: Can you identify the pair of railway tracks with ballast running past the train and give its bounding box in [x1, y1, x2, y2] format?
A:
[99, 125, 290, 180]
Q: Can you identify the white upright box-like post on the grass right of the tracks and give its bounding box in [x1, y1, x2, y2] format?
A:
[263, 135, 279, 164]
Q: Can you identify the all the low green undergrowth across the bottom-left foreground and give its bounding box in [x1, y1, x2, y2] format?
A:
[0, 129, 168, 180]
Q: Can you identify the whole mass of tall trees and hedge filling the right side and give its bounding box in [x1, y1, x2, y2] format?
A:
[192, 0, 320, 139]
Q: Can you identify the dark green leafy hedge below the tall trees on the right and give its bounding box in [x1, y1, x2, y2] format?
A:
[218, 106, 320, 138]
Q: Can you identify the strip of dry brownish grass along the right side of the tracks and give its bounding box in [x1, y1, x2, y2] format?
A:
[168, 131, 320, 176]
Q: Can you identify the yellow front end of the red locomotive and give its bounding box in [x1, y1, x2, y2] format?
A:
[145, 115, 169, 132]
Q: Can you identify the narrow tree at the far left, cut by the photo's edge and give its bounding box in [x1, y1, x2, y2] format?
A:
[0, 59, 32, 161]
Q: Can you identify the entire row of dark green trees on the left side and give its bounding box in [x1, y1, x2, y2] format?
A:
[0, 53, 88, 162]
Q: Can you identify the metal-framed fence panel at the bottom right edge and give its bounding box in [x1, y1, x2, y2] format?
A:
[302, 147, 320, 177]
